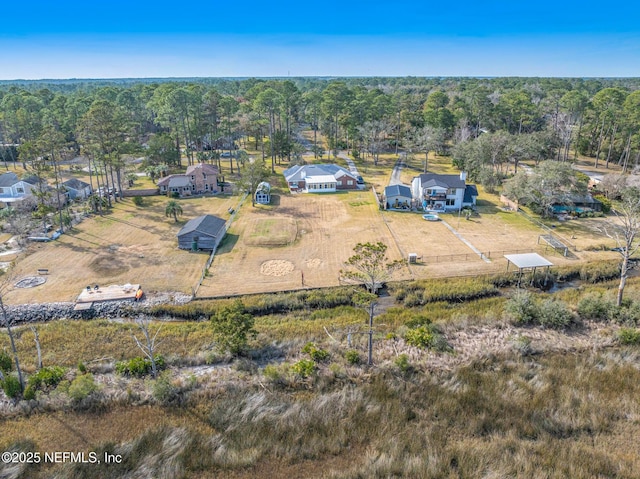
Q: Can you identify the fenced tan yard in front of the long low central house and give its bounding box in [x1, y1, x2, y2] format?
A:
[198, 191, 408, 297]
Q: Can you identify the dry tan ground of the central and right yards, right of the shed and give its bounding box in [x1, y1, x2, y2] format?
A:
[198, 191, 611, 297]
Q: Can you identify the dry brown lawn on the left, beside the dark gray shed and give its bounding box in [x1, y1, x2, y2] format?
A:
[5, 196, 239, 304]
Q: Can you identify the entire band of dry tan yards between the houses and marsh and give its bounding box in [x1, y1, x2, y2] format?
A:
[0, 178, 617, 304]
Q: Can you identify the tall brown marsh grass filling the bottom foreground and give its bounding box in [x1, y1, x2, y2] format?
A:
[8, 348, 640, 479]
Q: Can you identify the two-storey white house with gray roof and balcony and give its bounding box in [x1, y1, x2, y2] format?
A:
[411, 171, 478, 212]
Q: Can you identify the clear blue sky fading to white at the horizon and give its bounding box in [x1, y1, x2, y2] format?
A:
[0, 0, 640, 80]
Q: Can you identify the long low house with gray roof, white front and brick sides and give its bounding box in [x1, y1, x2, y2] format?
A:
[283, 165, 358, 193]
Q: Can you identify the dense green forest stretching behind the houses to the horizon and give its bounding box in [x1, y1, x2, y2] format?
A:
[0, 77, 640, 202]
